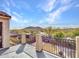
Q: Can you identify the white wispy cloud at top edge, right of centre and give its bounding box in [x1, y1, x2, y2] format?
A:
[38, 0, 56, 12]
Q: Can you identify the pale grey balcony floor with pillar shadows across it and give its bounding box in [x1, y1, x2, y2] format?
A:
[0, 44, 58, 58]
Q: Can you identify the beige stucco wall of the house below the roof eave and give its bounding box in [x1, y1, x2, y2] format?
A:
[0, 18, 10, 48]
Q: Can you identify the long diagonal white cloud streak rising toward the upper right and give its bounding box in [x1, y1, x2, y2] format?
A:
[47, 5, 70, 24]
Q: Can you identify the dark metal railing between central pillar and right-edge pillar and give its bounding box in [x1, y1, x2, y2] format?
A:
[43, 37, 76, 58]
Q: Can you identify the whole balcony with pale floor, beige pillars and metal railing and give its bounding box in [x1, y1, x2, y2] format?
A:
[0, 34, 78, 58]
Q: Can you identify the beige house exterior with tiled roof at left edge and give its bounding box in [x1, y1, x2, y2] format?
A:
[0, 11, 11, 48]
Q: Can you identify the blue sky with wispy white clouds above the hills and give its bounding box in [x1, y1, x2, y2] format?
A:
[0, 0, 79, 29]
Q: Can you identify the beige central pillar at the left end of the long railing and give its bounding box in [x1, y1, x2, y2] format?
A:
[36, 34, 43, 52]
